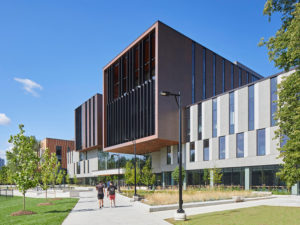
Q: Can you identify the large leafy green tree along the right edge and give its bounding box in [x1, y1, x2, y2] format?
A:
[260, 0, 300, 187]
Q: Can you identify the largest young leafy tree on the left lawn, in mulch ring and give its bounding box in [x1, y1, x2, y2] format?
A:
[6, 124, 39, 210]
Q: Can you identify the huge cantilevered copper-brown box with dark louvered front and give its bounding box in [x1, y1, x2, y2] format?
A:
[103, 21, 261, 154]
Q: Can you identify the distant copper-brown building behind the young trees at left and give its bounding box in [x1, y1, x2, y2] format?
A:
[40, 138, 75, 169]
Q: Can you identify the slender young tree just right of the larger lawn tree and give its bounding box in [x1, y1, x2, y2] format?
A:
[40, 148, 57, 199]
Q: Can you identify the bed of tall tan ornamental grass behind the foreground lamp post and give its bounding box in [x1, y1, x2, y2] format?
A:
[119, 188, 264, 205]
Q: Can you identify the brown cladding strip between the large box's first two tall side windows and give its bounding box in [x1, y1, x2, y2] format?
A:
[195, 43, 203, 102]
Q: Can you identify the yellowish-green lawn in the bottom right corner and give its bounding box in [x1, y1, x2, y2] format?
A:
[167, 206, 300, 225]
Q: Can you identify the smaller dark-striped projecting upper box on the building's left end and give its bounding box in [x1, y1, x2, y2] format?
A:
[75, 94, 103, 151]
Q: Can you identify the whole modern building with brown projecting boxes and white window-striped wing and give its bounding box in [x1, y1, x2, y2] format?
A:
[68, 21, 298, 193]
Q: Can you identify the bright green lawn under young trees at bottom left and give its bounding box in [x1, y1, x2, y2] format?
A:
[0, 196, 78, 225]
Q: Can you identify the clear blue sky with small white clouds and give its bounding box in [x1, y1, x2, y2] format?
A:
[0, 0, 281, 162]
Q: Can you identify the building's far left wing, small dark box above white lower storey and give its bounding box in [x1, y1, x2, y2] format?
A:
[67, 94, 148, 184]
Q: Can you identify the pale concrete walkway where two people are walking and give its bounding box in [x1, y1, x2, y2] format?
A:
[63, 191, 300, 225]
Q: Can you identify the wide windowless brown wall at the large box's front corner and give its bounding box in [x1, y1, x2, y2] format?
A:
[156, 23, 192, 141]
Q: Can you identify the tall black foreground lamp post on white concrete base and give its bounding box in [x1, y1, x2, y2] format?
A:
[160, 91, 186, 220]
